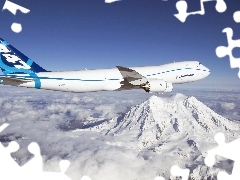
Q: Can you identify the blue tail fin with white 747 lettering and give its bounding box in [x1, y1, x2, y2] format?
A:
[0, 38, 47, 74]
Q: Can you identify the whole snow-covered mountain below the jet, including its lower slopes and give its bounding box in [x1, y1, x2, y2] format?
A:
[85, 94, 240, 177]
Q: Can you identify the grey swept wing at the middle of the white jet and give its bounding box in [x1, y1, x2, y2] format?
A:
[117, 66, 148, 90]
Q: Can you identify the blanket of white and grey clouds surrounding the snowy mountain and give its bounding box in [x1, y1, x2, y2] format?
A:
[0, 87, 240, 180]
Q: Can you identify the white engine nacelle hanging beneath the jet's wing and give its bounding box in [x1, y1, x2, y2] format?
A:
[140, 79, 173, 93]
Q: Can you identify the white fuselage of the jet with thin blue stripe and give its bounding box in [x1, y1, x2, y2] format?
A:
[15, 61, 210, 92]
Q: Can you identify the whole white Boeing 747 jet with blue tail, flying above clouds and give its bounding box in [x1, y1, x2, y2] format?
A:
[0, 38, 210, 93]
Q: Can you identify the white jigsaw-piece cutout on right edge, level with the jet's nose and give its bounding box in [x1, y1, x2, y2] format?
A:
[216, 27, 240, 78]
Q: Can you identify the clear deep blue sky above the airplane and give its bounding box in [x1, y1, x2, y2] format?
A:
[0, 0, 240, 88]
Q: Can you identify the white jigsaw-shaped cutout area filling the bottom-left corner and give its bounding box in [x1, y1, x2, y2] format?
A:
[0, 124, 91, 180]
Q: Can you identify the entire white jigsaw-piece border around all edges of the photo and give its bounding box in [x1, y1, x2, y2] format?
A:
[0, 0, 240, 180]
